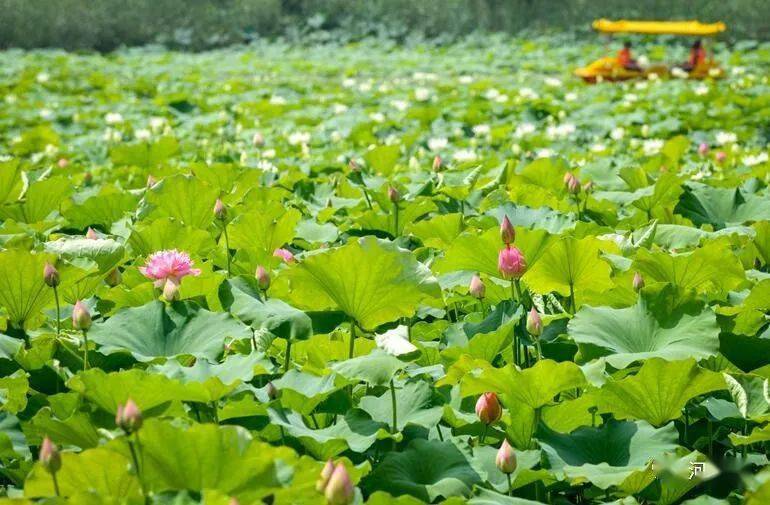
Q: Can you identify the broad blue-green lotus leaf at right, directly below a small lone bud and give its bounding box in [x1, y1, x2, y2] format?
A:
[567, 297, 719, 368]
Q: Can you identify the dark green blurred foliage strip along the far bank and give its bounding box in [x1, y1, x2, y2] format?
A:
[0, 0, 770, 51]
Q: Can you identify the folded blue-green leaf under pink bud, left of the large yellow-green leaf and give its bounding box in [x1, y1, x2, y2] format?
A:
[220, 277, 313, 340]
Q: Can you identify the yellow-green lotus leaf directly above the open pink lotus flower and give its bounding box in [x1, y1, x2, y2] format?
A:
[128, 217, 216, 256]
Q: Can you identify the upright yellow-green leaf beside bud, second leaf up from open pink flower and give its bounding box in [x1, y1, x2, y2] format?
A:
[145, 174, 219, 228]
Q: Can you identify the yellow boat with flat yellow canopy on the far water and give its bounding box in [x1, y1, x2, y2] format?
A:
[575, 19, 727, 83]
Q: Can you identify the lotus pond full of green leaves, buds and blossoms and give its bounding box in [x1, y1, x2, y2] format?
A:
[0, 35, 770, 505]
